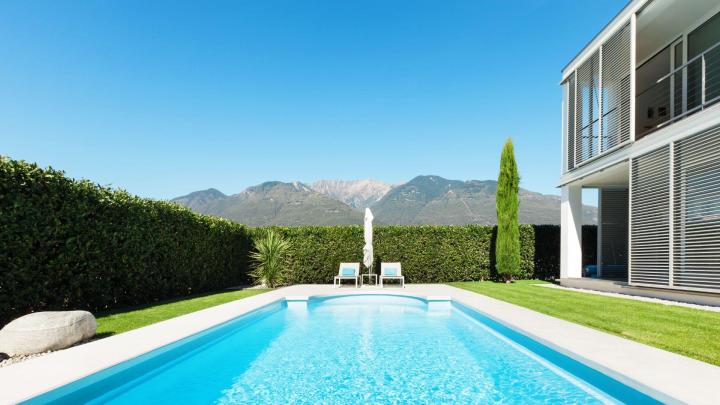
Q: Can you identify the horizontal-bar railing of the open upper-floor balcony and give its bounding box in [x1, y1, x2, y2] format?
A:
[636, 42, 720, 139]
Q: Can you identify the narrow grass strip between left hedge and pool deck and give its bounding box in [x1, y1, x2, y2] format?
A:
[97, 289, 270, 337]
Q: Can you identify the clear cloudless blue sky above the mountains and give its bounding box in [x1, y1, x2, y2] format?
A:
[0, 0, 627, 198]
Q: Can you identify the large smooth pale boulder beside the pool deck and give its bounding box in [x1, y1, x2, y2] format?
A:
[0, 311, 96, 356]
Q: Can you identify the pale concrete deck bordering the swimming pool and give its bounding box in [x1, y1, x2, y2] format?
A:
[0, 284, 720, 404]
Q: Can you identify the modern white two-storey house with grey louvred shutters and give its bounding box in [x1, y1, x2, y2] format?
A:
[559, 0, 720, 293]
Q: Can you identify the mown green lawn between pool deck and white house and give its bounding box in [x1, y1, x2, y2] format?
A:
[451, 280, 720, 365]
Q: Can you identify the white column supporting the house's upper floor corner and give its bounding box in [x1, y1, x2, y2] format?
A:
[560, 185, 582, 278]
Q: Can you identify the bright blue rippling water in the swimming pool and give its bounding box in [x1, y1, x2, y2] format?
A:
[29, 295, 654, 404]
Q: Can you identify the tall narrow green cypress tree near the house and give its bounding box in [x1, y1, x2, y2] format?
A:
[495, 138, 520, 282]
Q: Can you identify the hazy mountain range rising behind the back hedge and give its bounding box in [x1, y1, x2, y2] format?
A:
[171, 176, 597, 226]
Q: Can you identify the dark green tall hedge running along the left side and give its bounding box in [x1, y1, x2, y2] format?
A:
[0, 158, 249, 325]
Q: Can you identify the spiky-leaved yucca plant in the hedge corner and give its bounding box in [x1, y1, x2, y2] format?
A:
[250, 231, 290, 288]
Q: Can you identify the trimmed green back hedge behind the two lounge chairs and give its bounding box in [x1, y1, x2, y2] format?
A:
[250, 225, 595, 284]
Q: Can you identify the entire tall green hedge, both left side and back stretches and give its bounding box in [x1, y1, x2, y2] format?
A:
[0, 157, 596, 325]
